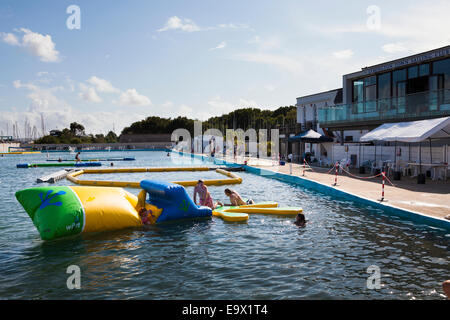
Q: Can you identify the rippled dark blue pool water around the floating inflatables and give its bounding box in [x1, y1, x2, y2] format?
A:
[0, 152, 450, 299]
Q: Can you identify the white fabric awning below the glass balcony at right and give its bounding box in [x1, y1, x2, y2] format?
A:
[360, 117, 450, 142]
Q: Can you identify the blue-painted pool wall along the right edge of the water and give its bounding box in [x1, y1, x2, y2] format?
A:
[178, 151, 450, 230]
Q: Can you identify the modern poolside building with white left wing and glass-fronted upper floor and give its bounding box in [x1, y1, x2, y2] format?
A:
[288, 46, 450, 166]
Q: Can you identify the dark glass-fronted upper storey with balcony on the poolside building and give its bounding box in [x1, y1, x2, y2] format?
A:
[318, 46, 450, 135]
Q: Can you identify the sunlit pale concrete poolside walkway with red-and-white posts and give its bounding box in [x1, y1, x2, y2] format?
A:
[212, 158, 450, 219]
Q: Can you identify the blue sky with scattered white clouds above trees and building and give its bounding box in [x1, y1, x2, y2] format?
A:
[0, 0, 450, 135]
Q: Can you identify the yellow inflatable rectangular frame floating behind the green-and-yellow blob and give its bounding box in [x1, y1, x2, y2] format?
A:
[67, 167, 242, 189]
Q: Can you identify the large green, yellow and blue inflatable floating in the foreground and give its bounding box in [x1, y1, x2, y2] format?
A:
[16, 180, 212, 240]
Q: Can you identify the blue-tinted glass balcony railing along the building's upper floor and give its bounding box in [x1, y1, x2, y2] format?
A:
[319, 90, 450, 127]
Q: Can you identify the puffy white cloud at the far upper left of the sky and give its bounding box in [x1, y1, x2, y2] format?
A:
[2, 28, 60, 62]
